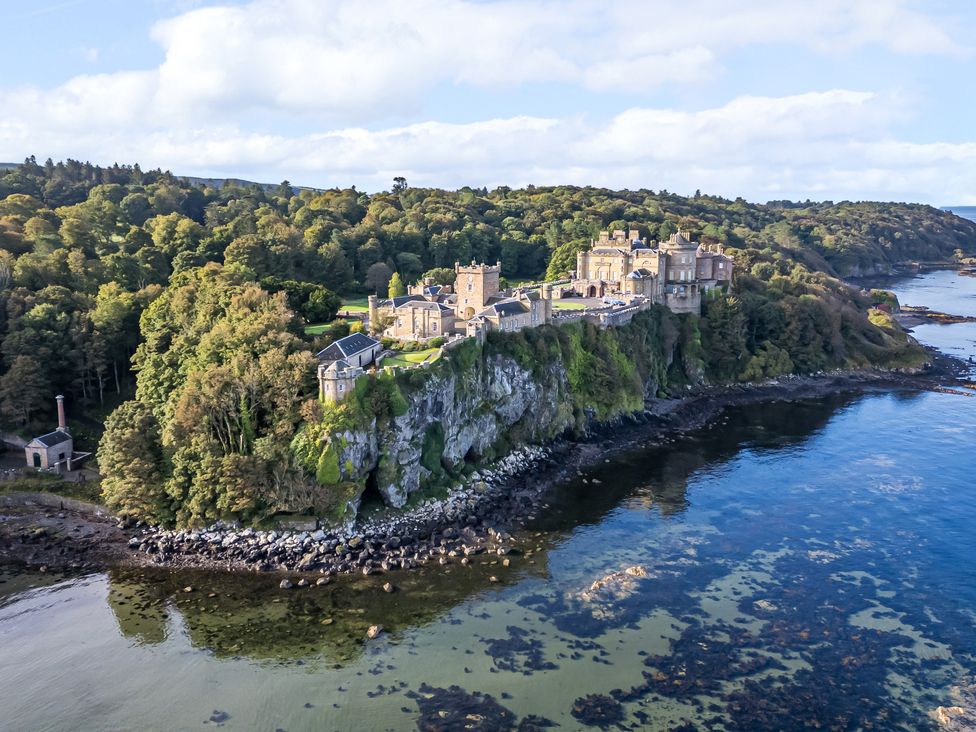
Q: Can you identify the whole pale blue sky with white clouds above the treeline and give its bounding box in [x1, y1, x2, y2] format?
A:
[0, 0, 976, 205]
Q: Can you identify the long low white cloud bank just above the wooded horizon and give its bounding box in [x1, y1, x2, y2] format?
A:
[0, 90, 976, 204]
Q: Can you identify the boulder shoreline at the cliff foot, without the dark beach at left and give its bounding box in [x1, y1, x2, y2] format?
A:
[116, 369, 943, 585]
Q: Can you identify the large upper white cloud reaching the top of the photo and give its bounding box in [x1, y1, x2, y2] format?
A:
[3, 0, 968, 124]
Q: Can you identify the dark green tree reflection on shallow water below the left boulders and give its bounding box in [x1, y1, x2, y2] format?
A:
[108, 560, 548, 663]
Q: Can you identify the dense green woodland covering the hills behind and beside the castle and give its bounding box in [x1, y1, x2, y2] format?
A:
[0, 159, 976, 524]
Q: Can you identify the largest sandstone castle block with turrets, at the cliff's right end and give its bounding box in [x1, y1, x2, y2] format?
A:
[573, 229, 732, 313]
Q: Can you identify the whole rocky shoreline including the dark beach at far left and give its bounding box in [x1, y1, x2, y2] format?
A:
[0, 349, 962, 588]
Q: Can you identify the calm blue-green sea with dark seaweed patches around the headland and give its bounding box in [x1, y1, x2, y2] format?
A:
[0, 273, 976, 730]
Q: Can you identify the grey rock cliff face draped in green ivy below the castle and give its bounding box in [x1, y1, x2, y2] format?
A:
[297, 309, 700, 521]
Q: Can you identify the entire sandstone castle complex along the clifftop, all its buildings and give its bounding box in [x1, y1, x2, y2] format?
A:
[318, 229, 732, 402]
